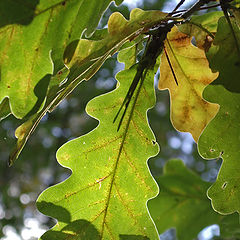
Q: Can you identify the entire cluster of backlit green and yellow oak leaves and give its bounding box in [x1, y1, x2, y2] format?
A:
[0, 0, 240, 240]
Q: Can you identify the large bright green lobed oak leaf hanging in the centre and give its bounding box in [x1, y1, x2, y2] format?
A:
[37, 50, 159, 240]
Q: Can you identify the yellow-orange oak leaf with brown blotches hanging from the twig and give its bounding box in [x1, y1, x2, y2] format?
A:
[159, 27, 219, 142]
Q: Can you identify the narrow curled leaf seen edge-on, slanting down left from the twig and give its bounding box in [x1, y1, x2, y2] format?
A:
[10, 9, 167, 165]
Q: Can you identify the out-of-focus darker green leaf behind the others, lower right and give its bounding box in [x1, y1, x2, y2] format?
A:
[148, 159, 223, 240]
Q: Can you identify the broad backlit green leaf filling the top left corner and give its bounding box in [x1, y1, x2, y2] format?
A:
[0, 0, 122, 118]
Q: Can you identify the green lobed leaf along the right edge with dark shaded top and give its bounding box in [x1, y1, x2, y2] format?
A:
[198, 17, 240, 214]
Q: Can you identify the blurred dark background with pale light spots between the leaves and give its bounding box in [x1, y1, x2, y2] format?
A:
[0, 0, 221, 240]
